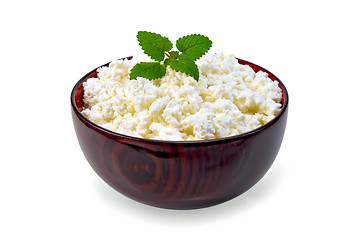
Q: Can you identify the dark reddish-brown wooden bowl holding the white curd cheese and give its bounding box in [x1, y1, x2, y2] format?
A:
[71, 59, 289, 209]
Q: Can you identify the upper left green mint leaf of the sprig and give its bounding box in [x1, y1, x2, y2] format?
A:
[137, 31, 173, 61]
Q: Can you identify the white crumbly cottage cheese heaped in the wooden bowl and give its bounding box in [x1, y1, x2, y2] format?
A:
[82, 54, 282, 141]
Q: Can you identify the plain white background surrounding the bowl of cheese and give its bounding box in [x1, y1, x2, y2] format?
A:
[0, 0, 360, 239]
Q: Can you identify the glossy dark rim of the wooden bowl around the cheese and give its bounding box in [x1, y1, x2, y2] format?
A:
[70, 56, 289, 145]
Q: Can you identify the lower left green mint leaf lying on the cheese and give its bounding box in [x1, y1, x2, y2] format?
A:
[130, 62, 166, 80]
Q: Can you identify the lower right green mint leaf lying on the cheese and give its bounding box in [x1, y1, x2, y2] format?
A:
[164, 53, 199, 81]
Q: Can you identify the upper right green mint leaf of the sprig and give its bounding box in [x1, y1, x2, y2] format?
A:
[176, 34, 212, 60]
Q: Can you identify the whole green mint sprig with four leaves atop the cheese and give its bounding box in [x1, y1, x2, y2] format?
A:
[130, 31, 212, 80]
